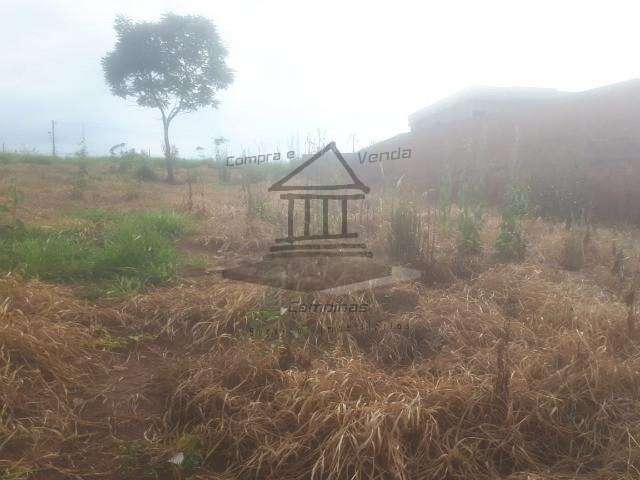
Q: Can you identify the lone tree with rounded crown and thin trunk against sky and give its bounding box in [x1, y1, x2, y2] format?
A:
[102, 13, 233, 182]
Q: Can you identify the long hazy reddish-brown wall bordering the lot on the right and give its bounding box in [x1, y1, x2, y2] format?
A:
[354, 81, 640, 221]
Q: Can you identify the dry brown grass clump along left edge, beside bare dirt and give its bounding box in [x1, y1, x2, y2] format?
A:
[0, 277, 99, 478]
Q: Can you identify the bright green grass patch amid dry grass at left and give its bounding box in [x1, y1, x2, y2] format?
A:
[0, 209, 194, 296]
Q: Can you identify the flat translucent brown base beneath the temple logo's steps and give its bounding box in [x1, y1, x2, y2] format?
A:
[222, 257, 421, 295]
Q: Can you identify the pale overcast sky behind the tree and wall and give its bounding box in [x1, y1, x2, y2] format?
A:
[0, 0, 640, 157]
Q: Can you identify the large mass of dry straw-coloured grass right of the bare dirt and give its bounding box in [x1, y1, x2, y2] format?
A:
[125, 264, 640, 478]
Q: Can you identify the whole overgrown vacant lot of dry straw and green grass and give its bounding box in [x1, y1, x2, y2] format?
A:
[0, 159, 640, 480]
